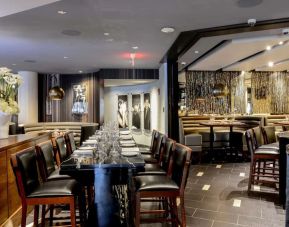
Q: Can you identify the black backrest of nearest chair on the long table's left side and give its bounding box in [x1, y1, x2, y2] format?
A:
[10, 147, 40, 199]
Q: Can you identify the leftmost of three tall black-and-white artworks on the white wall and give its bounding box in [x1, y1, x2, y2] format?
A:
[117, 95, 128, 128]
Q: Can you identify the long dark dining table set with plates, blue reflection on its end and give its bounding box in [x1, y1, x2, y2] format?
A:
[60, 129, 145, 227]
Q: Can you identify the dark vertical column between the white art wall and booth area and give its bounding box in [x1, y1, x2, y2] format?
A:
[167, 59, 179, 141]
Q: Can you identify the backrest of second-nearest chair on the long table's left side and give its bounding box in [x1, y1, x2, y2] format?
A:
[35, 140, 55, 181]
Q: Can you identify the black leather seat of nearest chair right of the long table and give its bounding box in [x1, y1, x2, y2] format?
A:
[135, 175, 179, 191]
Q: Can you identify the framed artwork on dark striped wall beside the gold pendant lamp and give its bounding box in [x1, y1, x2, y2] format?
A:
[72, 84, 88, 115]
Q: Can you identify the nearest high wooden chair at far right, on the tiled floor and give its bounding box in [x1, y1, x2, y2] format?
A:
[245, 129, 279, 191]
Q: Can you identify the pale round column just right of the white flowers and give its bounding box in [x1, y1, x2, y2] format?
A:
[18, 71, 38, 124]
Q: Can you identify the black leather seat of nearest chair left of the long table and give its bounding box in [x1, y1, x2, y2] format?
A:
[27, 180, 79, 198]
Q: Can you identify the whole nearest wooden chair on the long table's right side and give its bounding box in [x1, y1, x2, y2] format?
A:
[134, 143, 192, 227]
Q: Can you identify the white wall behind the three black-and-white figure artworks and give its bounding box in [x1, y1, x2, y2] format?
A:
[104, 64, 168, 145]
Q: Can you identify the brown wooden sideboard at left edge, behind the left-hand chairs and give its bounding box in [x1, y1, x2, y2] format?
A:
[0, 133, 51, 225]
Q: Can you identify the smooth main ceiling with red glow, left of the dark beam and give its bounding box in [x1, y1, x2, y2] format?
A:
[0, 0, 289, 73]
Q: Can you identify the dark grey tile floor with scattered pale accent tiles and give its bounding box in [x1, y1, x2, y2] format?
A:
[20, 163, 285, 227]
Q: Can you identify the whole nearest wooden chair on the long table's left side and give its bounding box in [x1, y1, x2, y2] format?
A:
[10, 147, 81, 227]
